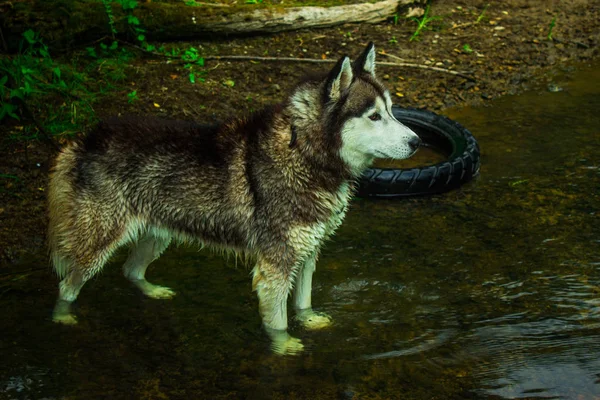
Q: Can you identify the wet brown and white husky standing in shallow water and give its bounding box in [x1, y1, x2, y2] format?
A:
[48, 43, 420, 354]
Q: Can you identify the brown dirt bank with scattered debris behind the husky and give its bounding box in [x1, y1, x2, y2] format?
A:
[0, 0, 600, 266]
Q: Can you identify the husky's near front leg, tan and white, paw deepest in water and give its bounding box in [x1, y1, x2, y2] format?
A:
[252, 260, 304, 355]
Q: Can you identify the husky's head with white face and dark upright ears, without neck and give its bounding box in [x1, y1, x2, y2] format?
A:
[324, 43, 421, 173]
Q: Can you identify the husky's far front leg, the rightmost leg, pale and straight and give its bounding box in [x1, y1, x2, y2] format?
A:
[294, 253, 333, 329]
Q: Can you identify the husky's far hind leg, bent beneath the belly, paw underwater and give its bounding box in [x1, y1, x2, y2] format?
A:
[123, 234, 175, 299]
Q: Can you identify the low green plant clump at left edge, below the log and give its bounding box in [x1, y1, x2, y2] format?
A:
[0, 30, 135, 139]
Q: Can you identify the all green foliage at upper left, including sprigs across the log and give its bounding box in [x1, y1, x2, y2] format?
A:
[0, 0, 211, 139]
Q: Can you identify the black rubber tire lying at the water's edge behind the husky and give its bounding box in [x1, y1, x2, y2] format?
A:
[357, 106, 480, 198]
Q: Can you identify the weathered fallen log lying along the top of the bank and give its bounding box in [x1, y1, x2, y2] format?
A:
[0, 0, 415, 51]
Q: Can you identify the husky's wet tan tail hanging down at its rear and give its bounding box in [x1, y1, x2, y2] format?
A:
[48, 143, 79, 279]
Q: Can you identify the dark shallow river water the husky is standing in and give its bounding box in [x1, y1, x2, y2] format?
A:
[0, 66, 600, 399]
